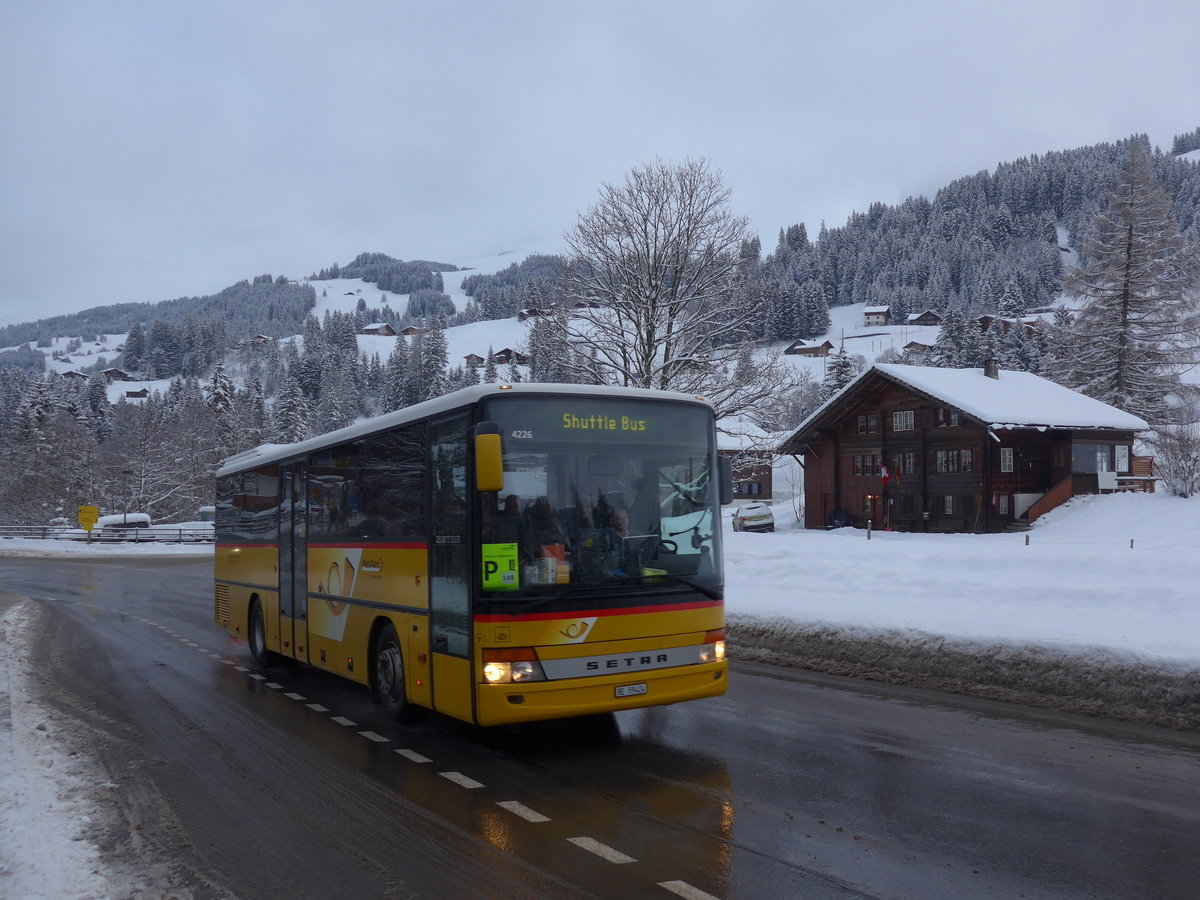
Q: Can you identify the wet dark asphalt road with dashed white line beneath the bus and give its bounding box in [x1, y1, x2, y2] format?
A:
[0, 559, 1200, 898]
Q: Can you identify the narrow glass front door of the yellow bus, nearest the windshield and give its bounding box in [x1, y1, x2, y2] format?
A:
[430, 415, 475, 721]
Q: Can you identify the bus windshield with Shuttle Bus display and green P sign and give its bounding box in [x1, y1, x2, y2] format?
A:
[480, 396, 724, 601]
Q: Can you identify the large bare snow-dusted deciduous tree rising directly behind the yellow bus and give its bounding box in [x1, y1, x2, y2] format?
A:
[560, 161, 790, 415]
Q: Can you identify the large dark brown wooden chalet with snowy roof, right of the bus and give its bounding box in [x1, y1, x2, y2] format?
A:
[780, 364, 1147, 533]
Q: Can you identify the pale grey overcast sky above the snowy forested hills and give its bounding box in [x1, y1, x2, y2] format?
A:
[0, 0, 1200, 323]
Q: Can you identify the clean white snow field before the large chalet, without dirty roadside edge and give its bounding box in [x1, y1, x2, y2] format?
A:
[725, 493, 1200, 668]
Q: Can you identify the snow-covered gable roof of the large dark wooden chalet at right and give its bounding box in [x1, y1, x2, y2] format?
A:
[781, 362, 1150, 448]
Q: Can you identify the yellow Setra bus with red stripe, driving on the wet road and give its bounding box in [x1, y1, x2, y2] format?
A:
[215, 384, 731, 726]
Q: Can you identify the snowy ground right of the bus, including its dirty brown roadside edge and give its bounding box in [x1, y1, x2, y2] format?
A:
[725, 494, 1200, 730]
